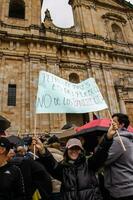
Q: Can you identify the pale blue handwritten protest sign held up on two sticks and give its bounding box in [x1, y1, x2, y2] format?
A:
[36, 71, 107, 113]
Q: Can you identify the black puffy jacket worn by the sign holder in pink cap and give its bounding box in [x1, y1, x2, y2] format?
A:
[41, 137, 112, 200]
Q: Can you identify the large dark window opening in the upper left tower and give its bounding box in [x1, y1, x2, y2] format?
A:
[9, 0, 25, 19]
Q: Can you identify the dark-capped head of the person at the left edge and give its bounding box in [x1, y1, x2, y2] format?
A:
[0, 137, 11, 156]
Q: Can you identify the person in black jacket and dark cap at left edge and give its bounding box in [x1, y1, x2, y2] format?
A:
[0, 137, 25, 200]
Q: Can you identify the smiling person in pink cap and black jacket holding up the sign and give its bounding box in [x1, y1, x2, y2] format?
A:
[35, 125, 115, 200]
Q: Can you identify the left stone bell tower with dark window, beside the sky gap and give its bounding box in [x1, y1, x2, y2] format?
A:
[0, 0, 43, 27]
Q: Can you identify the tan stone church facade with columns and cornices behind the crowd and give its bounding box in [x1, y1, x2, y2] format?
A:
[0, 0, 133, 133]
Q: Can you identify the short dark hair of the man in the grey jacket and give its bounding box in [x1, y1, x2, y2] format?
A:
[112, 113, 130, 128]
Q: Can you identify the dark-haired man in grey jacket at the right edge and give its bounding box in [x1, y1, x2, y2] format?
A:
[105, 113, 133, 200]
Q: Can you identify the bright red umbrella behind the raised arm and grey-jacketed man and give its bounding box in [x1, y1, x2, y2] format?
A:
[76, 118, 133, 134]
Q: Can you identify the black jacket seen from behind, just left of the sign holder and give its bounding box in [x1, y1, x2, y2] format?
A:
[12, 157, 52, 200]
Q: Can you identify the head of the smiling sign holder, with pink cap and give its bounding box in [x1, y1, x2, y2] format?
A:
[66, 138, 84, 161]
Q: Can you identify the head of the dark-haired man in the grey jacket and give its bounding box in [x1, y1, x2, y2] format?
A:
[112, 113, 130, 128]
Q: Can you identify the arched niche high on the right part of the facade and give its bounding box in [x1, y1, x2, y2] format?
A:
[112, 24, 124, 42]
